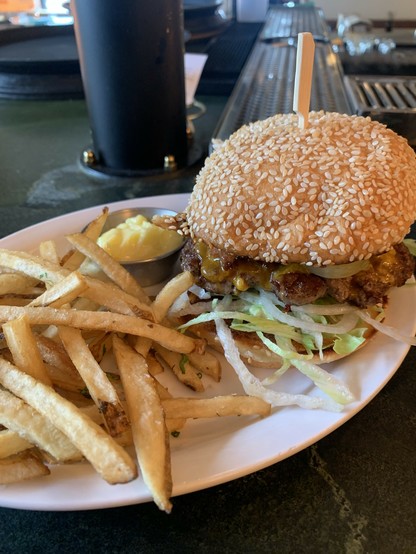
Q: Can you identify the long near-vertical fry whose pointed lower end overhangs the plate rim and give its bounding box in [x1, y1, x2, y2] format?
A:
[113, 335, 172, 513]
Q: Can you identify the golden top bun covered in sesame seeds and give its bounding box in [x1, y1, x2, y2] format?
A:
[186, 112, 416, 266]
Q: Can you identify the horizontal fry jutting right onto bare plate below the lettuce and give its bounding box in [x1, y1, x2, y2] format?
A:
[162, 395, 271, 419]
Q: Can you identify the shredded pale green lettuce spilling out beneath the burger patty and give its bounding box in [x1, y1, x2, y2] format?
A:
[173, 289, 383, 411]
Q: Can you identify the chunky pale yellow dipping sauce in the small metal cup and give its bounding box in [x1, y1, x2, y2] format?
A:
[97, 215, 182, 262]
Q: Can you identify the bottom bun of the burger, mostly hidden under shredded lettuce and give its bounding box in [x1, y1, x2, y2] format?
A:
[180, 322, 377, 369]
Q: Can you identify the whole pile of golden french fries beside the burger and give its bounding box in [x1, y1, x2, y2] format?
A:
[0, 209, 270, 512]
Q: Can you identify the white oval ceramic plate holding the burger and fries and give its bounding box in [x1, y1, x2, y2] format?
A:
[0, 194, 416, 510]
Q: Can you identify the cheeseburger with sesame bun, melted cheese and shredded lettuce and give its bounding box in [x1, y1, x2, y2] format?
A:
[154, 112, 416, 408]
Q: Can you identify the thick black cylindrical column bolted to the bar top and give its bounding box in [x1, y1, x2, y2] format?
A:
[72, 0, 188, 177]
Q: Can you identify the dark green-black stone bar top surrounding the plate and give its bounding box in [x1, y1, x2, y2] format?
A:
[0, 33, 416, 554]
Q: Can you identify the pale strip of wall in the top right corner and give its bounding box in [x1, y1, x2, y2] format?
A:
[315, 0, 416, 20]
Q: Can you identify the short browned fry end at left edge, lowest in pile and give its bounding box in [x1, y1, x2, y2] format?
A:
[0, 451, 50, 485]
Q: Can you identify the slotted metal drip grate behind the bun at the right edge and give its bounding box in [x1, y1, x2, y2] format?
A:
[344, 75, 416, 149]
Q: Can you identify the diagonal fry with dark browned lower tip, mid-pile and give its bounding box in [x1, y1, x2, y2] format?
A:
[59, 327, 130, 437]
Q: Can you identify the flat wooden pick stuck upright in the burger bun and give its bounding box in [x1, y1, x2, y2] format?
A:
[293, 33, 315, 129]
